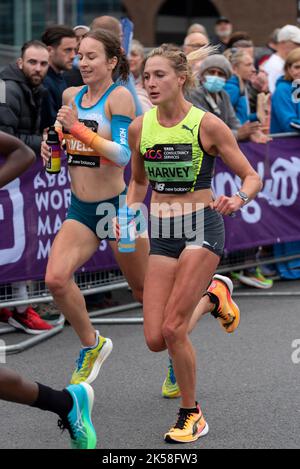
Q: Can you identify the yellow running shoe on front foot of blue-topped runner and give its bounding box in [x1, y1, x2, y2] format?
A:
[71, 331, 113, 384]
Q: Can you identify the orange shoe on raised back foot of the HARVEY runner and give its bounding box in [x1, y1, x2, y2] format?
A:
[207, 274, 240, 334]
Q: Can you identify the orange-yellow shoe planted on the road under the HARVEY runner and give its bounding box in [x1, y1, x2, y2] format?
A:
[165, 404, 209, 443]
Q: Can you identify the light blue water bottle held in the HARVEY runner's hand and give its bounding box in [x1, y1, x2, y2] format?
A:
[118, 205, 135, 252]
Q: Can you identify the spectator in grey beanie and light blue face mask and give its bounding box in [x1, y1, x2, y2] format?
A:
[187, 54, 260, 140]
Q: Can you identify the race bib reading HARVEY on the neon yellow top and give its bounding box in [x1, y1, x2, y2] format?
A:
[144, 144, 195, 194]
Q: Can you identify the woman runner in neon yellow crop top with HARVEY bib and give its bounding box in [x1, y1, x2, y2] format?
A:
[127, 46, 261, 443]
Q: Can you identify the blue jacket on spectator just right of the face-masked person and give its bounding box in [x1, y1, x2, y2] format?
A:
[224, 75, 257, 124]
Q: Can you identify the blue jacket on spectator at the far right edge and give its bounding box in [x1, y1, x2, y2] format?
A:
[271, 77, 300, 133]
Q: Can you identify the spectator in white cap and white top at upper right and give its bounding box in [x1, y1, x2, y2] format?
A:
[263, 24, 300, 93]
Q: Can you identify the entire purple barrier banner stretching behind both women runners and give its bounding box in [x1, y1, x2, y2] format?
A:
[0, 138, 300, 283]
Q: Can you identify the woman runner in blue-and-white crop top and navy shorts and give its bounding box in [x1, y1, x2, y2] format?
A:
[41, 30, 149, 384]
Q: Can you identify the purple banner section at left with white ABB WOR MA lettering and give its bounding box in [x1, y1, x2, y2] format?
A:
[0, 157, 116, 283]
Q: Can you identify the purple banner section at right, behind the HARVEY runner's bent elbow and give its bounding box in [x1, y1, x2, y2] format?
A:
[213, 137, 300, 252]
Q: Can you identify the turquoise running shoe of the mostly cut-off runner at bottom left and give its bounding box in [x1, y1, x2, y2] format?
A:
[58, 383, 97, 449]
